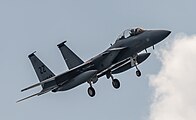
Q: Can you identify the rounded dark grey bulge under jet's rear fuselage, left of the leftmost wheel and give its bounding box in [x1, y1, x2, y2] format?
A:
[58, 70, 97, 91]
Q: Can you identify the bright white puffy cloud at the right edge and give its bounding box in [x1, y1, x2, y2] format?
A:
[149, 36, 196, 120]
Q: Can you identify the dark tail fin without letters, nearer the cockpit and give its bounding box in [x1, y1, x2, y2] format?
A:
[57, 41, 84, 69]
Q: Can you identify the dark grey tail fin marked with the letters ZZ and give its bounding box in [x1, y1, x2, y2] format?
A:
[28, 52, 56, 89]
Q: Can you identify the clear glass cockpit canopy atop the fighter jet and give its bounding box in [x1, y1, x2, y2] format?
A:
[117, 28, 144, 40]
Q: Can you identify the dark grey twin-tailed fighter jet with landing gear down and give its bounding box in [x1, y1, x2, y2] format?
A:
[17, 28, 171, 102]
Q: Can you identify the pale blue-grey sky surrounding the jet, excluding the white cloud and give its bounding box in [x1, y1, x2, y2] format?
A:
[0, 0, 196, 120]
